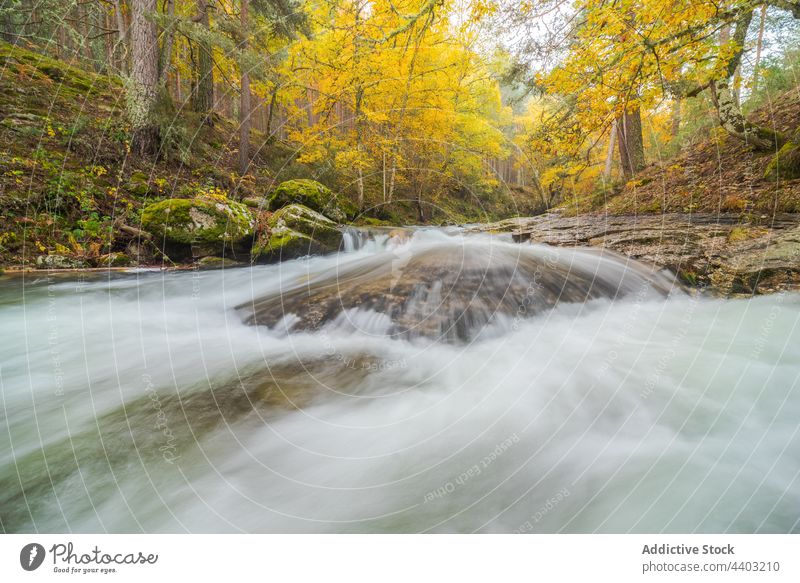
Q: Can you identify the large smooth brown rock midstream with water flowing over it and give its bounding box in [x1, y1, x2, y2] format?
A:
[241, 237, 674, 341]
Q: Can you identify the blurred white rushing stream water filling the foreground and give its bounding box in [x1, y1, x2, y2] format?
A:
[0, 232, 800, 532]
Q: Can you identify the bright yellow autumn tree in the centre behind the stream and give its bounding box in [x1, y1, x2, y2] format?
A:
[283, 0, 511, 221]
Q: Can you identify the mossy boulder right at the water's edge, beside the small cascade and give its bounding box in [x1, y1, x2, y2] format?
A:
[250, 204, 342, 263]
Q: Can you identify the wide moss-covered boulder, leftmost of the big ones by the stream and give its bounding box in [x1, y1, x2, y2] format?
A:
[142, 197, 256, 256]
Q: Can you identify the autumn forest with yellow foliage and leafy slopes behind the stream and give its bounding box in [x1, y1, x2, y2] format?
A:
[0, 0, 800, 264]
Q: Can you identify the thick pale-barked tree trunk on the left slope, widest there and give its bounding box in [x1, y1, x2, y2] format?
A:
[127, 0, 159, 156]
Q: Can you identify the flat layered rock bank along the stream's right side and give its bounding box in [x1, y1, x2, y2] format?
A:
[471, 213, 800, 296]
